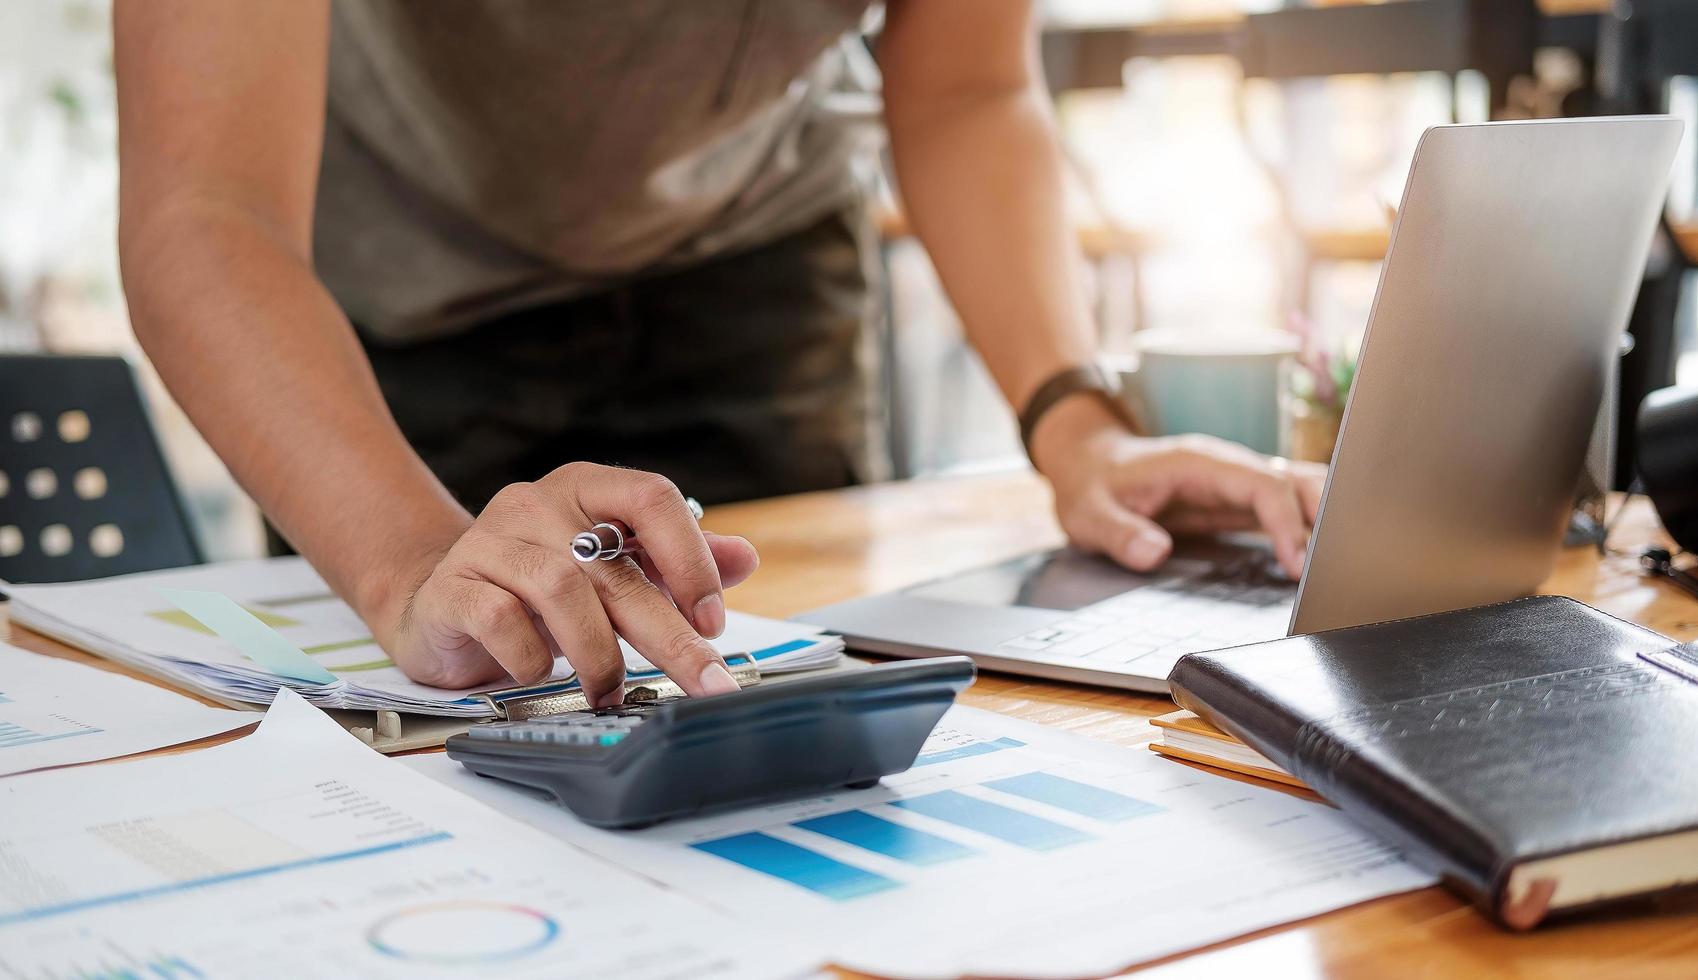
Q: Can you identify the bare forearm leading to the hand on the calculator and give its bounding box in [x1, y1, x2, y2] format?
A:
[121, 202, 470, 622]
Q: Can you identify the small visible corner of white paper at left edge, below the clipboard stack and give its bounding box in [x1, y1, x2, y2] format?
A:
[0, 644, 260, 776]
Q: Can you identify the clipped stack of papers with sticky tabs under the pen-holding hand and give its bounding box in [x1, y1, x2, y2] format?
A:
[5, 557, 844, 718]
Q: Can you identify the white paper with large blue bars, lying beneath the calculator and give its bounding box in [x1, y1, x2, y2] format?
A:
[402, 707, 1433, 977]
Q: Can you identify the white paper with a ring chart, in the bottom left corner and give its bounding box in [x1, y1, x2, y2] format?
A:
[0, 691, 818, 980]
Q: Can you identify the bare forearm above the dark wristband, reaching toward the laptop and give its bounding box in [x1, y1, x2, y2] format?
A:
[886, 79, 1097, 408]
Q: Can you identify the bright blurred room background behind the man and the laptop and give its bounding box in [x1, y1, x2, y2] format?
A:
[0, 0, 1698, 559]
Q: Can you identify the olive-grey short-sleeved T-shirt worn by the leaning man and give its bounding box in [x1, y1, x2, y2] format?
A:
[312, 0, 868, 343]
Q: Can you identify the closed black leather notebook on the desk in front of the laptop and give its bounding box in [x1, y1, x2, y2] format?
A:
[1168, 596, 1698, 929]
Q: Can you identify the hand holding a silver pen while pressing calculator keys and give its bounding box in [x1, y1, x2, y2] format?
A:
[377, 462, 759, 707]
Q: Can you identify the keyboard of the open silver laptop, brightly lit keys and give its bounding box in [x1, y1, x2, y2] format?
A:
[997, 550, 1297, 678]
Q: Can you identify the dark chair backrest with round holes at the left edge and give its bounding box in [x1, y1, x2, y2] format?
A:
[0, 353, 202, 583]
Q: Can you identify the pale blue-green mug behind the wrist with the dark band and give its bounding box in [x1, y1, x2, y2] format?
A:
[1110, 329, 1297, 453]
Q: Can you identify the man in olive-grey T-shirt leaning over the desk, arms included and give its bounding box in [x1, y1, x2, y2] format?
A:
[114, 0, 1318, 703]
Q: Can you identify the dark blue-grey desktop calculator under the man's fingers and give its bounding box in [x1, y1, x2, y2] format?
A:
[448, 657, 973, 827]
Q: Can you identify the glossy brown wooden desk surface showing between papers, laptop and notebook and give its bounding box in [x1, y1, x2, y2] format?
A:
[12, 474, 1698, 980]
